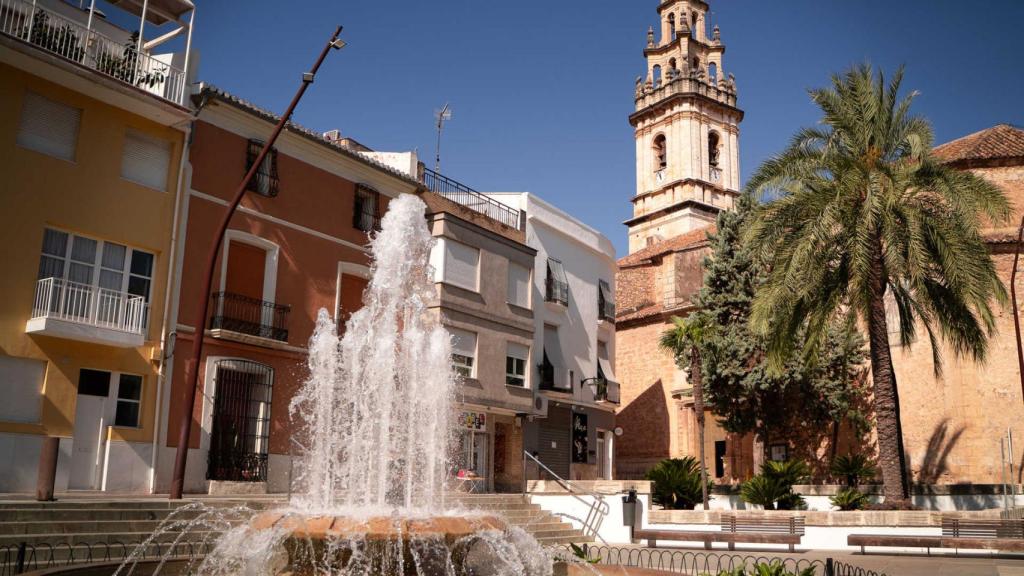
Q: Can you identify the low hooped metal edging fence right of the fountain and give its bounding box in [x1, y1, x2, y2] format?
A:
[555, 544, 885, 576]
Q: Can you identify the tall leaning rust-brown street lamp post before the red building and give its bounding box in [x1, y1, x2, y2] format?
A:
[164, 26, 345, 500]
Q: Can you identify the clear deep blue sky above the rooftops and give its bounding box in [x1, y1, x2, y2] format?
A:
[172, 0, 1024, 255]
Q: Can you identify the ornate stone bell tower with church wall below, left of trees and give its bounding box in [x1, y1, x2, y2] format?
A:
[615, 0, 752, 482]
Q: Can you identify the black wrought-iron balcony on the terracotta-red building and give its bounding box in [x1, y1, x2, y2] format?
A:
[210, 292, 292, 345]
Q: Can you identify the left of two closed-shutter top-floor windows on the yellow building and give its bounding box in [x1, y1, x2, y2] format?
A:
[17, 92, 82, 161]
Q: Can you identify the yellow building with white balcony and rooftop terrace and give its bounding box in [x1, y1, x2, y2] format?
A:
[0, 0, 194, 492]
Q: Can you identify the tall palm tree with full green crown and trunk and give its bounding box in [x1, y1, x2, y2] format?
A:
[744, 65, 1010, 503]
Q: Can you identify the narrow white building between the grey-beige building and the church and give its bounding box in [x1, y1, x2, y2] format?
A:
[487, 193, 618, 480]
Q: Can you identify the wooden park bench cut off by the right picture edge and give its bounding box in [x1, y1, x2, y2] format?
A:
[846, 518, 1024, 553]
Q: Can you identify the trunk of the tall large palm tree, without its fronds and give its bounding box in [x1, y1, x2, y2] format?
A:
[867, 246, 907, 503]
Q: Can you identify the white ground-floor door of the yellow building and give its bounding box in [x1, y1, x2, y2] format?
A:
[68, 370, 111, 490]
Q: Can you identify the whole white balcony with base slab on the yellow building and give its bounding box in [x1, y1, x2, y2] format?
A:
[25, 278, 146, 347]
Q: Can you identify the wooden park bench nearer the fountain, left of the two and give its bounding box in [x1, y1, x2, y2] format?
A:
[633, 515, 804, 551]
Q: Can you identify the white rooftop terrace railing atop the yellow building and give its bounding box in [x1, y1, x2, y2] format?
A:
[0, 0, 185, 105]
